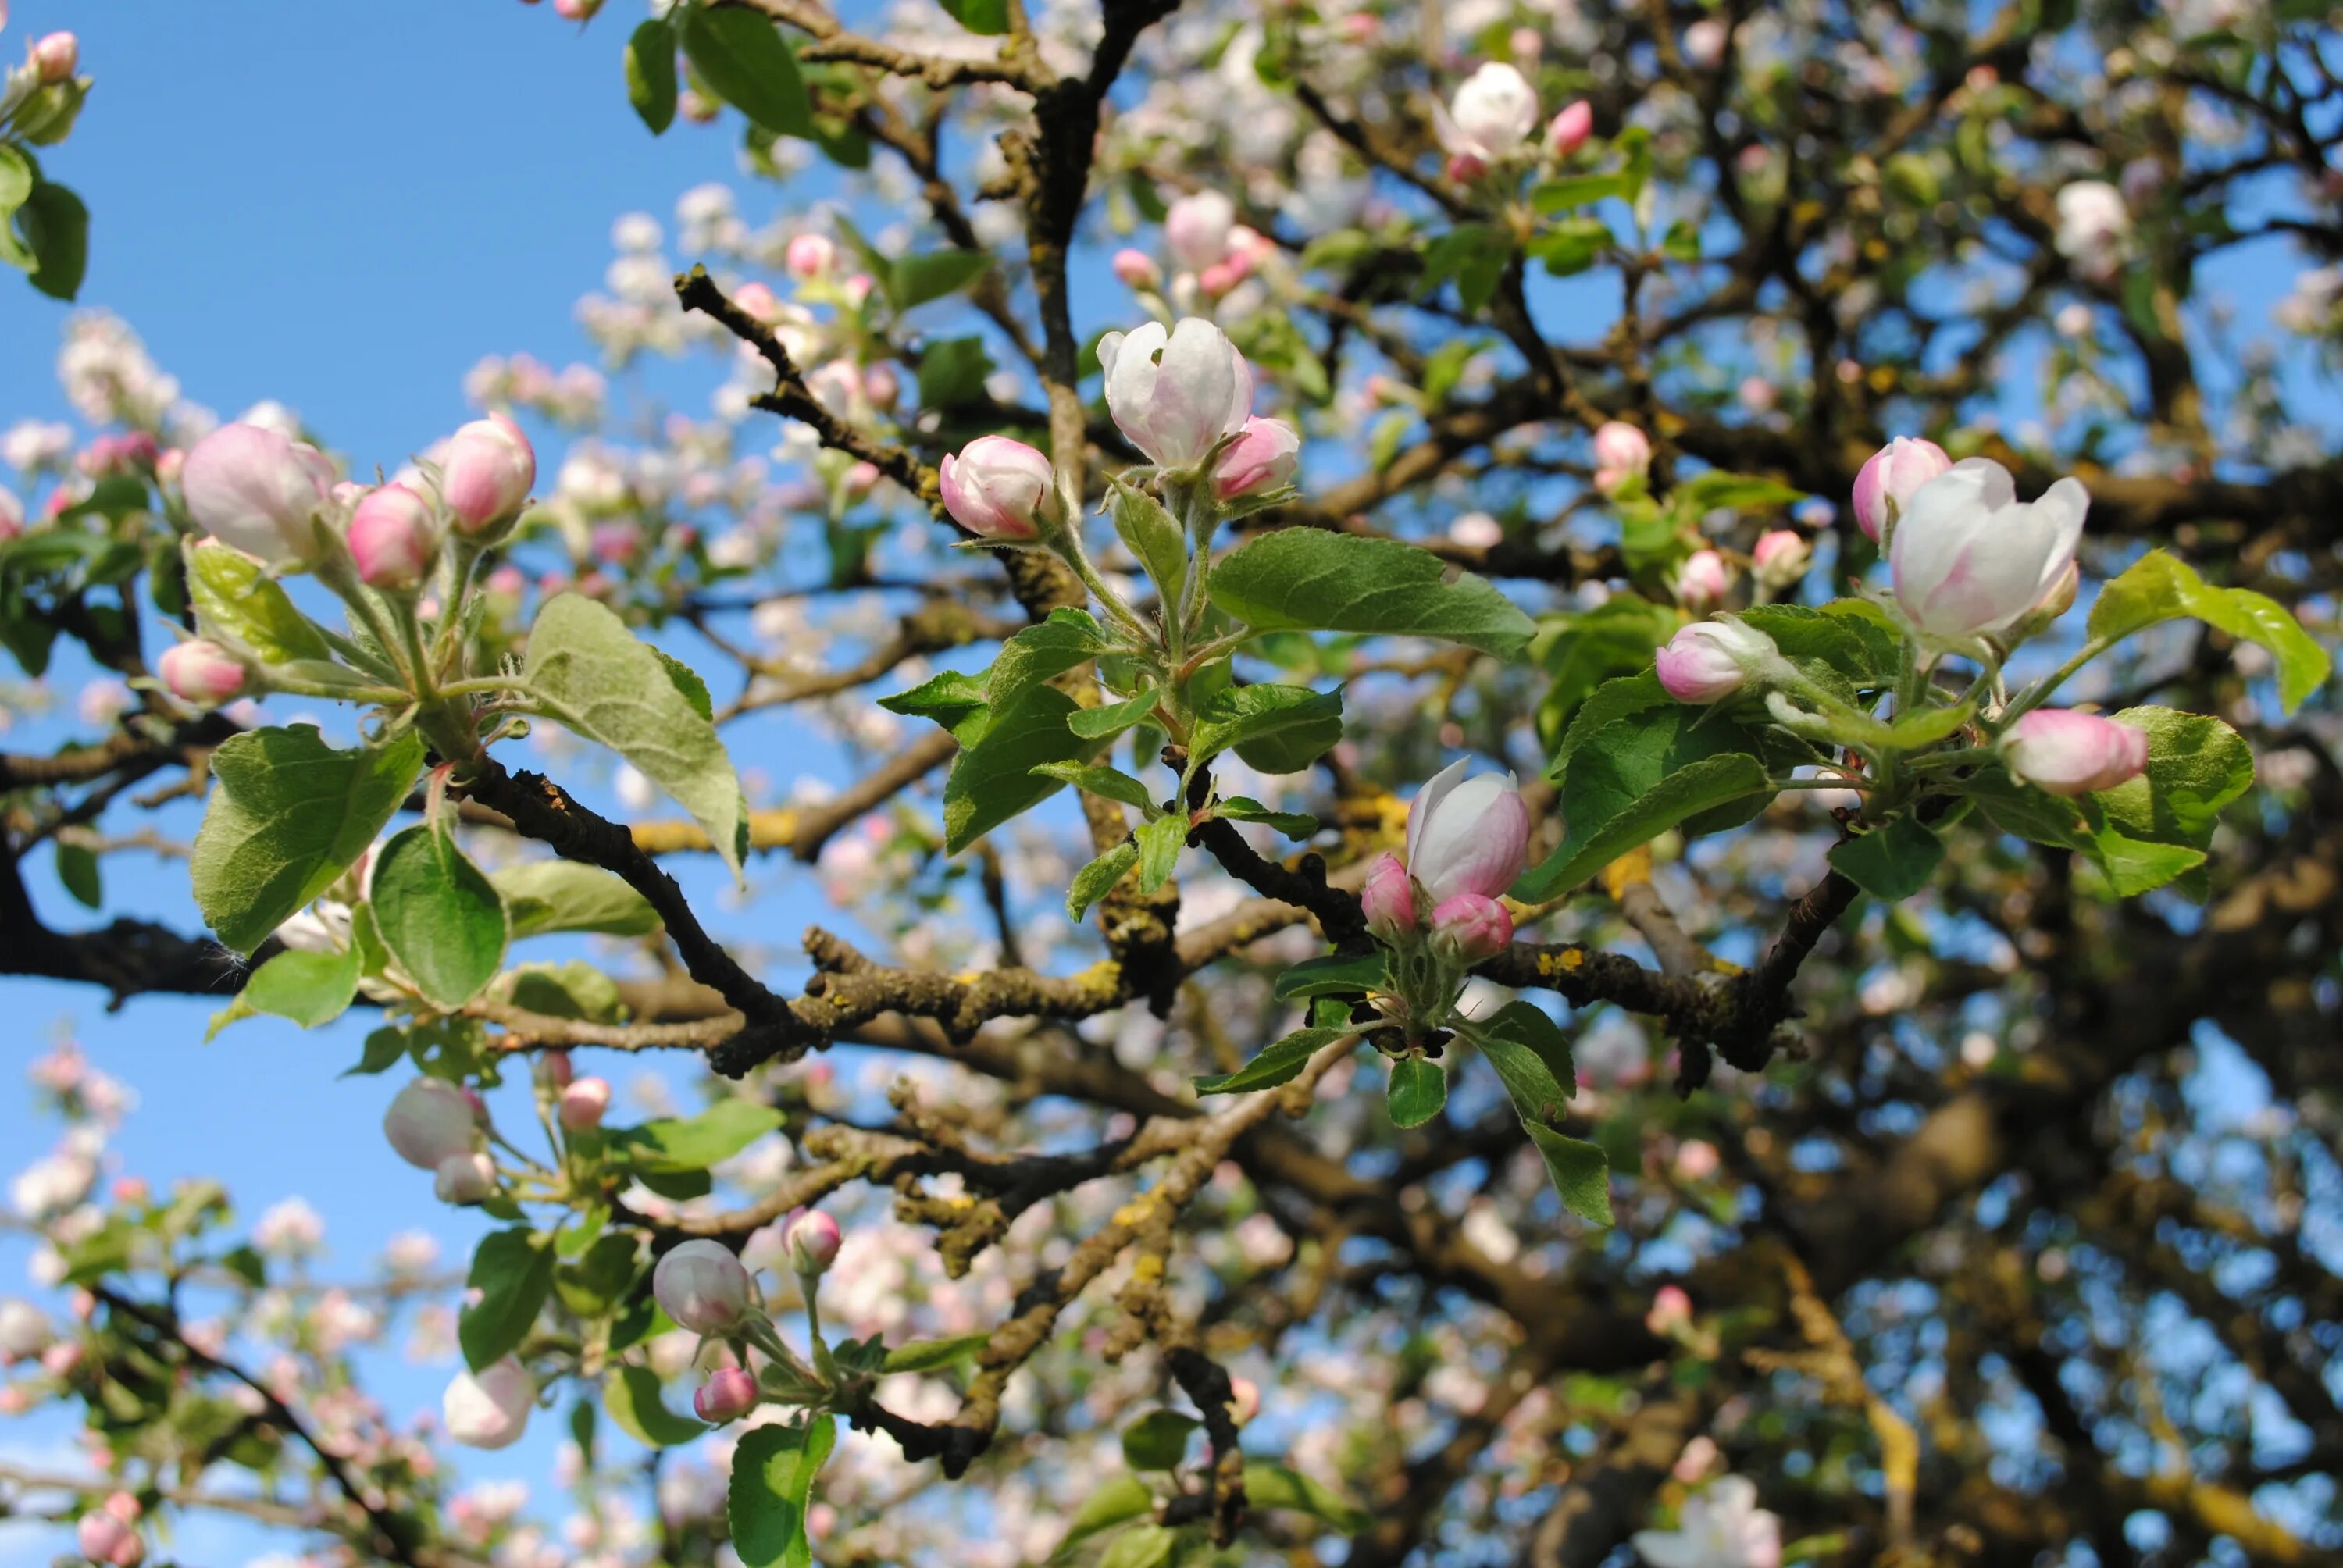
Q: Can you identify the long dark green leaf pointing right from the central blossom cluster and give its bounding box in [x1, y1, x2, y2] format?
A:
[1204, 527, 1537, 658]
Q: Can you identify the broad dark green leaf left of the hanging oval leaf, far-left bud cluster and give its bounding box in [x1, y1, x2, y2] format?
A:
[190, 724, 424, 954]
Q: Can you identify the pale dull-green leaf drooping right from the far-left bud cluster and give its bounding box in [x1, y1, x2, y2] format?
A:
[522, 590, 745, 877]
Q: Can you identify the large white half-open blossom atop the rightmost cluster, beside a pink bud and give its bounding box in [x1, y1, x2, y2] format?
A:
[1888, 457, 2090, 637]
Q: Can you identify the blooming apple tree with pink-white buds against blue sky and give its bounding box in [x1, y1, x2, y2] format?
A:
[0, 0, 2343, 1568]
